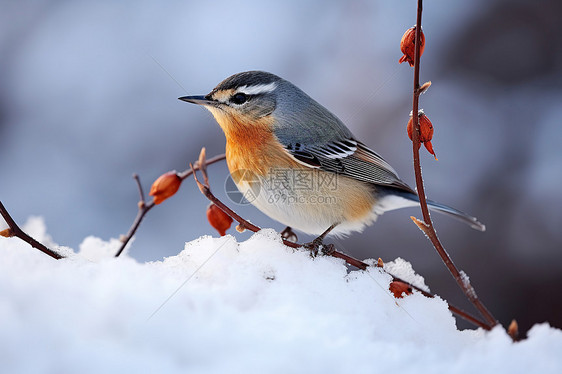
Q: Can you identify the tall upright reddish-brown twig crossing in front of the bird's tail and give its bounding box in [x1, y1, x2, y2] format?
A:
[406, 0, 498, 326]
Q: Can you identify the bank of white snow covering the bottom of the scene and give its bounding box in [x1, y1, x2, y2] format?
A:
[0, 218, 562, 373]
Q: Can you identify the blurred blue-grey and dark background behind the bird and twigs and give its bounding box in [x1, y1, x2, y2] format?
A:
[0, 0, 562, 331]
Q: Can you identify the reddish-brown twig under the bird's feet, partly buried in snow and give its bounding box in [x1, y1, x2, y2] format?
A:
[190, 148, 491, 330]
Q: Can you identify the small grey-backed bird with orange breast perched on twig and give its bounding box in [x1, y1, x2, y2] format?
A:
[179, 71, 485, 243]
